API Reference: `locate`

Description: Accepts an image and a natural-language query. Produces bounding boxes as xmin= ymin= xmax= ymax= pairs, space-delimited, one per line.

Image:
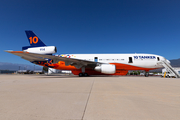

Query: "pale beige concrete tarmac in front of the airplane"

xmin=0 ymin=75 xmax=180 ymax=120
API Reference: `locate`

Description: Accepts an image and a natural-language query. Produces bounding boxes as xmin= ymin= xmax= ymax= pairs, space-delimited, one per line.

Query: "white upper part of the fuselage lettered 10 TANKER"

xmin=59 ymin=54 xmax=169 ymax=68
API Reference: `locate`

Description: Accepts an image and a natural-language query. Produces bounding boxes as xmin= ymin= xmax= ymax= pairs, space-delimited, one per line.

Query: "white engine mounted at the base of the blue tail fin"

xmin=23 ymin=46 xmax=57 ymax=54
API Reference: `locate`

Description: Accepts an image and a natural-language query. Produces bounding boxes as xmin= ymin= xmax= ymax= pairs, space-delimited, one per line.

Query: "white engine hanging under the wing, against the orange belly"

xmin=94 ymin=64 xmax=116 ymax=74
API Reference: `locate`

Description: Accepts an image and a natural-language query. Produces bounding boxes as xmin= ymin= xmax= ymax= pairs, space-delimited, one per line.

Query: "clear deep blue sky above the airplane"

xmin=0 ymin=0 xmax=180 ymax=64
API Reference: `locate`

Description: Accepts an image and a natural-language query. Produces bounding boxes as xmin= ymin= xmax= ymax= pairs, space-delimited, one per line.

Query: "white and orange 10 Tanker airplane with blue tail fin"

xmin=6 ymin=30 xmax=170 ymax=77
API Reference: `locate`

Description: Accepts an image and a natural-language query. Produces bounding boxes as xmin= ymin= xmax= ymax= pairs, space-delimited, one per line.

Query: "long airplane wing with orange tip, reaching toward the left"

xmin=5 ymin=51 xmax=100 ymax=69
